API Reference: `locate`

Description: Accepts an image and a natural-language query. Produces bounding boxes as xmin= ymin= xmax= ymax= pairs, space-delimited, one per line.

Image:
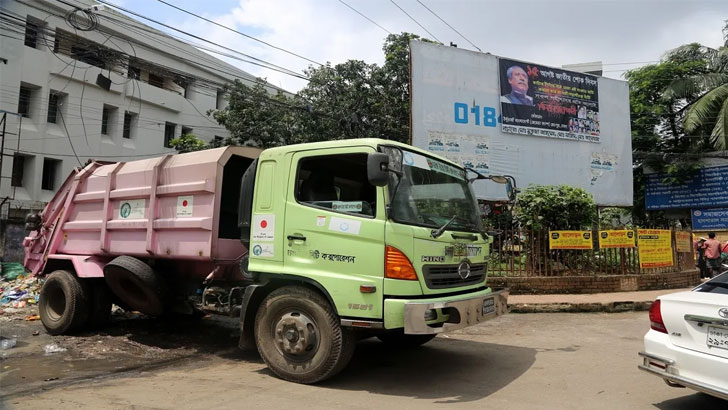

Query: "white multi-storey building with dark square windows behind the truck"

xmin=0 ymin=0 xmax=278 ymax=211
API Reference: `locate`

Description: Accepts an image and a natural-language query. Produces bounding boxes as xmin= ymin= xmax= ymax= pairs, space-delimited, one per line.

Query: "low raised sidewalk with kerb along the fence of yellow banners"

xmin=508 ymin=288 xmax=692 ymax=313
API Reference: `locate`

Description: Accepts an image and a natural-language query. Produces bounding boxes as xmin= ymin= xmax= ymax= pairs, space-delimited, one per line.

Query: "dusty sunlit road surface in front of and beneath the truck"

xmin=0 ymin=312 xmax=728 ymax=410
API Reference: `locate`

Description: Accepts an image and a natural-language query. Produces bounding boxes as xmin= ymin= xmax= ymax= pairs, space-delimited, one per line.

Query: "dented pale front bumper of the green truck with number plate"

xmin=384 ymin=288 xmax=509 ymax=335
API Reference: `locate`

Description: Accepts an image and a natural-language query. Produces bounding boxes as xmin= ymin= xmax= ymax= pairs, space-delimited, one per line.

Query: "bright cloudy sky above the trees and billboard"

xmin=109 ymin=0 xmax=728 ymax=92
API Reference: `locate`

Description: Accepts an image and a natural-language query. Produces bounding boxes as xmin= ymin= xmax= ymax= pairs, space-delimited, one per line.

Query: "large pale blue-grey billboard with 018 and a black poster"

xmin=410 ymin=41 xmax=632 ymax=206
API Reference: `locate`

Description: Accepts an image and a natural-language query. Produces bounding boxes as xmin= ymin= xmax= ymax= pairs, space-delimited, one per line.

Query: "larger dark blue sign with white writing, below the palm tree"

xmin=645 ymin=166 xmax=728 ymax=211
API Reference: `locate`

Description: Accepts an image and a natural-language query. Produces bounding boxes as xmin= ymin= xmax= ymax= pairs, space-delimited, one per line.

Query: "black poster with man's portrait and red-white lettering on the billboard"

xmin=498 ymin=58 xmax=600 ymax=142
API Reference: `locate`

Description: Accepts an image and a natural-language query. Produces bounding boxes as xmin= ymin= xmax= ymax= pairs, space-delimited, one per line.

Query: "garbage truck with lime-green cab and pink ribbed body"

xmin=23 ymin=139 xmax=515 ymax=383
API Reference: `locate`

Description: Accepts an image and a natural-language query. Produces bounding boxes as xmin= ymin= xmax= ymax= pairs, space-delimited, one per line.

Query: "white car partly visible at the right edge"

xmin=639 ymin=265 xmax=728 ymax=400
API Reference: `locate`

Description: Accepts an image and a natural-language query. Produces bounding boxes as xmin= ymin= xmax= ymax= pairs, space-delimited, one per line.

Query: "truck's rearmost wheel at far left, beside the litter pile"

xmin=38 ymin=270 xmax=88 ymax=335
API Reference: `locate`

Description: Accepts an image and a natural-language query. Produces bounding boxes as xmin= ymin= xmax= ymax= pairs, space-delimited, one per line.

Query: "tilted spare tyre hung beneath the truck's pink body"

xmin=104 ymin=256 xmax=168 ymax=316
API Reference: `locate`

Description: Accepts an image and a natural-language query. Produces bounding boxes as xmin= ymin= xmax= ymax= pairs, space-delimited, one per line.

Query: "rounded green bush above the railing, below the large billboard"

xmin=516 ymin=185 xmax=597 ymax=231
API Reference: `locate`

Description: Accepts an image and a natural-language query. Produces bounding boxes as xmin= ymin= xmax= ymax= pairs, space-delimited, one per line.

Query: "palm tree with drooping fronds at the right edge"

xmin=664 ymin=24 xmax=728 ymax=151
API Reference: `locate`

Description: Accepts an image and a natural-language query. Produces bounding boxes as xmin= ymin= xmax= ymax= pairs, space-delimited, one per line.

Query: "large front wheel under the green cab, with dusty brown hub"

xmin=255 ymin=286 xmax=356 ymax=384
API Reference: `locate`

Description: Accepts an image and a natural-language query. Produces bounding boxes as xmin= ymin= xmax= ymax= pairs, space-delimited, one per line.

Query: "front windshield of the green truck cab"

xmin=382 ymin=147 xmax=481 ymax=232
